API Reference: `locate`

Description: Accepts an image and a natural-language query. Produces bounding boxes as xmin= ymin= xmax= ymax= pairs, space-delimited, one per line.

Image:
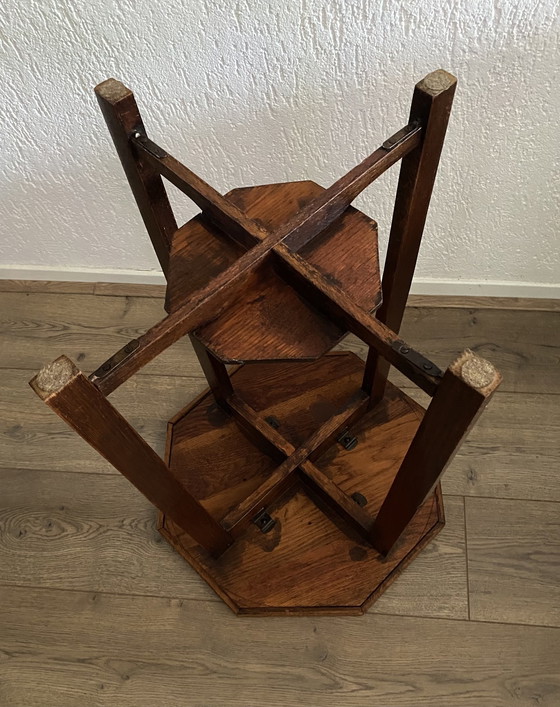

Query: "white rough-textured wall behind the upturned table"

xmin=0 ymin=0 xmax=560 ymax=290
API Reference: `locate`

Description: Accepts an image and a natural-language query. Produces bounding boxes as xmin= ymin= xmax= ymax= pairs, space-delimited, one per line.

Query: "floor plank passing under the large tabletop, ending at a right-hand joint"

xmin=0 ymin=469 xmax=467 ymax=618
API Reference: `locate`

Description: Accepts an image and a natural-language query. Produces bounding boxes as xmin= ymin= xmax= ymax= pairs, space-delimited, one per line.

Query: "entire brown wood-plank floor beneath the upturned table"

xmin=0 ymin=282 xmax=560 ymax=707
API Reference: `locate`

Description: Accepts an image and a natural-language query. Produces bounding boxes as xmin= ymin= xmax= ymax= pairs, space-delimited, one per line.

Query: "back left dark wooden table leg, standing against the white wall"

xmin=95 ymin=79 xmax=177 ymax=273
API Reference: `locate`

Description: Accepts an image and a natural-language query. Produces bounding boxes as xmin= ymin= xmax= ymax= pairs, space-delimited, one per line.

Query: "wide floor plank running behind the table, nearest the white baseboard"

xmin=0 ymin=292 xmax=560 ymax=393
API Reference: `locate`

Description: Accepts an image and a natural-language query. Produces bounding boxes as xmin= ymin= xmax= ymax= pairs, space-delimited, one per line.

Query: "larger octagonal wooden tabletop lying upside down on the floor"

xmin=159 ymin=352 xmax=445 ymax=615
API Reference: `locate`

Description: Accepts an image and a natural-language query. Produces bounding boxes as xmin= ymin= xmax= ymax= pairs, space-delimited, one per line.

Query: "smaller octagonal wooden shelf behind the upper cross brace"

xmin=167 ymin=181 xmax=381 ymax=363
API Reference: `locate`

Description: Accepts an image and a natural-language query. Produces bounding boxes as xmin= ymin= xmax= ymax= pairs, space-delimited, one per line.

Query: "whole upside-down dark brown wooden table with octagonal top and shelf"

xmin=25 ymin=71 xmax=500 ymax=614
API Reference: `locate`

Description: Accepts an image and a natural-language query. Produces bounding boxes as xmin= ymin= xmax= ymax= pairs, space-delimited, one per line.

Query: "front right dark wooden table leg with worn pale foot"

xmin=371 ymin=350 xmax=502 ymax=554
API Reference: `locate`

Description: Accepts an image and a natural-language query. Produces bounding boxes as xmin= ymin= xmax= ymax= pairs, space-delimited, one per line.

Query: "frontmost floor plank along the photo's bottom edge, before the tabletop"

xmin=0 ymin=587 xmax=560 ymax=707
